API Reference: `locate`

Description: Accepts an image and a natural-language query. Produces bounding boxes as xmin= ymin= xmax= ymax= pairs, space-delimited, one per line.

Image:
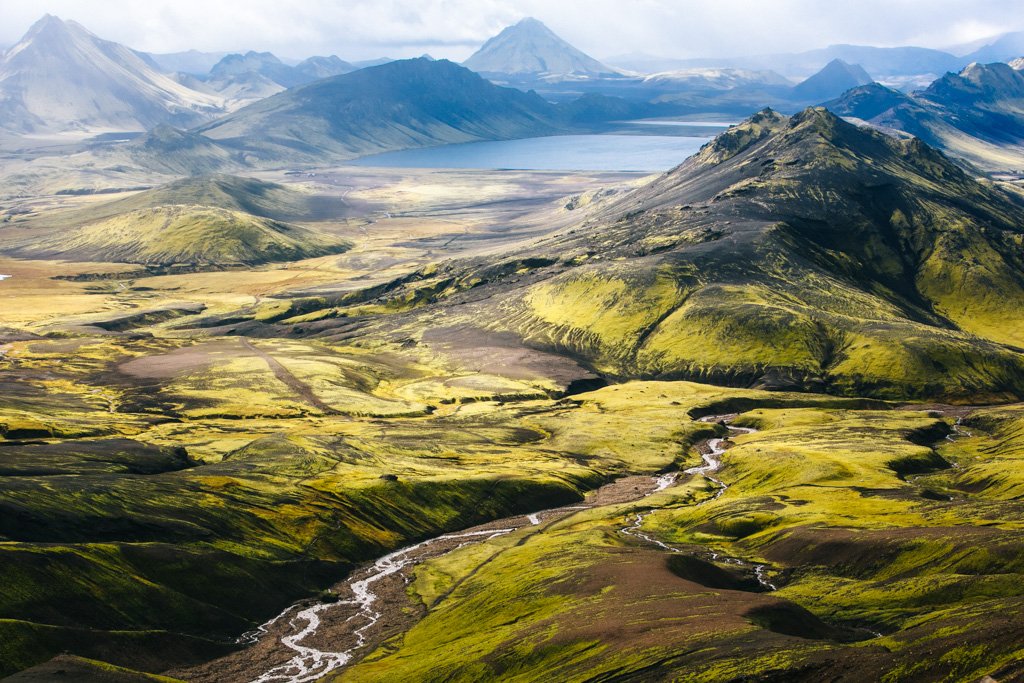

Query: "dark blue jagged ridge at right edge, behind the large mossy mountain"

xmin=826 ymin=62 xmax=1024 ymax=171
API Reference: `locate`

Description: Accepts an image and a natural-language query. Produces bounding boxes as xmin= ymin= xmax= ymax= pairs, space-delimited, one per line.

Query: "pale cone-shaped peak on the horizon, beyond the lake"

xmin=463 ymin=17 xmax=617 ymax=77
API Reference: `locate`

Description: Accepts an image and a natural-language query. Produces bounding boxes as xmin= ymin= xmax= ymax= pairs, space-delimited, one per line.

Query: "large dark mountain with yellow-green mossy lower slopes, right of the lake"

xmin=254 ymin=109 xmax=1024 ymax=401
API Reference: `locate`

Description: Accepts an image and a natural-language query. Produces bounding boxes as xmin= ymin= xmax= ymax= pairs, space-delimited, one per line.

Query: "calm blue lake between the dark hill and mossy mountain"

xmin=350 ymin=135 xmax=711 ymax=172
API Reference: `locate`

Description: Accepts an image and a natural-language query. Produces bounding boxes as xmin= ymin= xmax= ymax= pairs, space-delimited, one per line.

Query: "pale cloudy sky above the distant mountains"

xmin=0 ymin=0 xmax=1024 ymax=60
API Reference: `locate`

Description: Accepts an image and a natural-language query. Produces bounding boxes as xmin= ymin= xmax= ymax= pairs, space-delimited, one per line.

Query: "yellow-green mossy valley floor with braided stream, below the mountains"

xmin=0 ymin=168 xmax=1024 ymax=682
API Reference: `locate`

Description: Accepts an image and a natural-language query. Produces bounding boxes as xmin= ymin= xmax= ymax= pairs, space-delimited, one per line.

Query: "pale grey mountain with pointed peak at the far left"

xmin=0 ymin=14 xmax=223 ymax=133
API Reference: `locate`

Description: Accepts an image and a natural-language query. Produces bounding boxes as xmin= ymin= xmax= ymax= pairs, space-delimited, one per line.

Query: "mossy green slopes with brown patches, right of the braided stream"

xmin=336 ymin=401 xmax=1024 ymax=681
